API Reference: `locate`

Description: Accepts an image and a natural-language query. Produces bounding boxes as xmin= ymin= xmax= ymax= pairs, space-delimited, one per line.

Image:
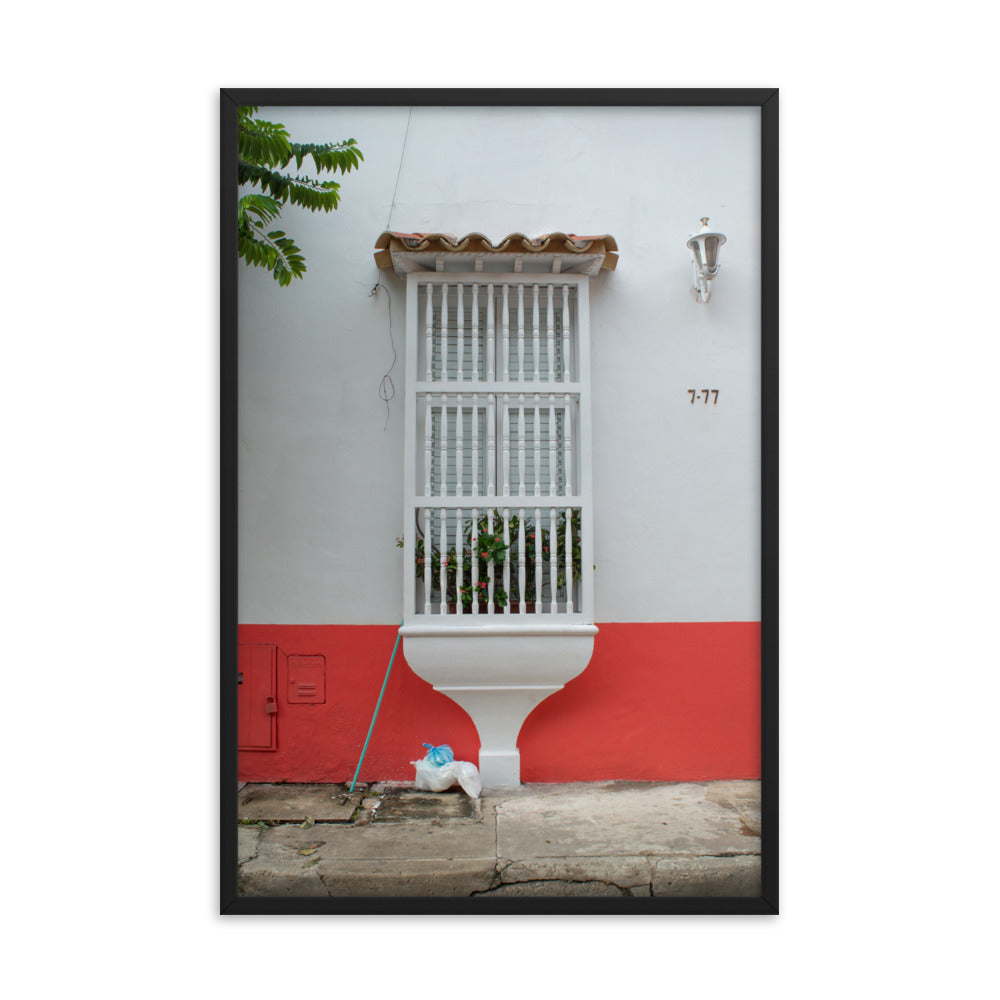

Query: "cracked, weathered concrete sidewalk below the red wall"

xmin=238 ymin=781 xmax=761 ymax=898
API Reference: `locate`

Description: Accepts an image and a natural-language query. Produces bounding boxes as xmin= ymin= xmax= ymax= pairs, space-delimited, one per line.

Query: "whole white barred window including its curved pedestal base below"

xmin=380 ymin=237 xmax=617 ymax=788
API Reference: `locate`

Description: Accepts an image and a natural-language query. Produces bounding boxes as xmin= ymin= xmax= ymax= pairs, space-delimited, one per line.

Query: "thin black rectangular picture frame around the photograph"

xmin=219 ymin=88 xmax=779 ymax=914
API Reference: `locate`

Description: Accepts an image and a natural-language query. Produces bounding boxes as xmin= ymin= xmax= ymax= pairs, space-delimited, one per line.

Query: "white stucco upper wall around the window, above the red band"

xmin=238 ymin=107 xmax=760 ymax=624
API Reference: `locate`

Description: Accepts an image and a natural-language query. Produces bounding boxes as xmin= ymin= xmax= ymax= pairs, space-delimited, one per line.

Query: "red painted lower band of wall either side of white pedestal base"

xmin=239 ymin=622 xmax=760 ymax=782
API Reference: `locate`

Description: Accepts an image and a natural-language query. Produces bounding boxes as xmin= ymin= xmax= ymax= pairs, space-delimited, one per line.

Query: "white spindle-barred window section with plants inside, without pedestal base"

xmin=404 ymin=272 xmax=593 ymax=624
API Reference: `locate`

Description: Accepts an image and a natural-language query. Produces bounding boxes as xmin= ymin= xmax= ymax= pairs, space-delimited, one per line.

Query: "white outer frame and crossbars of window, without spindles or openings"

xmin=403 ymin=271 xmax=594 ymax=632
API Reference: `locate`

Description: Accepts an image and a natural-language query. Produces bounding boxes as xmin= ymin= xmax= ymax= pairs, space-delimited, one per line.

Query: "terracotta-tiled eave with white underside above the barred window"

xmin=375 ymin=231 xmax=618 ymax=277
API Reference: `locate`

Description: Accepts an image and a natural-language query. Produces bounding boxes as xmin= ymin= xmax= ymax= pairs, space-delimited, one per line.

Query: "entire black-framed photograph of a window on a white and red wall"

xmin=220 ymin=89 xmax=778 ymax=914
